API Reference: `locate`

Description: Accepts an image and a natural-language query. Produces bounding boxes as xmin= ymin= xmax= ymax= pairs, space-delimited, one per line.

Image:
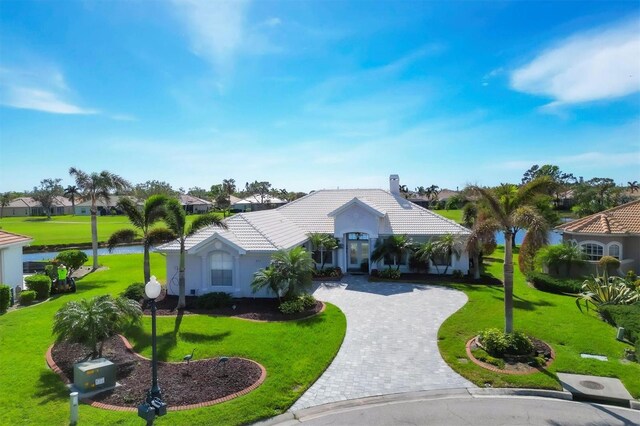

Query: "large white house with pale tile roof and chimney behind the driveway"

xmin=157 ymin=175 xmax=470 ymax=297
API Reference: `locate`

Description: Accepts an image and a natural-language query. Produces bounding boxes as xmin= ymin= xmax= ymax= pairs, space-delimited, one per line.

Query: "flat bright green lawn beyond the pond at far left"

xmin=0 ymin=215 xmax=222 ymax=245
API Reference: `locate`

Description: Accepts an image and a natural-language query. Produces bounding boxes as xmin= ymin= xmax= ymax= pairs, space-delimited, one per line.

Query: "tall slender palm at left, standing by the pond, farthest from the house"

xmin=69 ymin=167 xmax=131 ymax=270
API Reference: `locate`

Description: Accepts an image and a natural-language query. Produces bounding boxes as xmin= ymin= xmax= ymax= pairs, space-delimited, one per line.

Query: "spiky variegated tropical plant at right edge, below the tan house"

xmin=576 ymin=271 xmax=640 ymax=311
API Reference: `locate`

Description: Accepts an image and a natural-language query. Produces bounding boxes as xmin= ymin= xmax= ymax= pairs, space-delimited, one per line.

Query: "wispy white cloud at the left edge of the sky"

xmin=0 ymin=66 xmax=98 ymax=115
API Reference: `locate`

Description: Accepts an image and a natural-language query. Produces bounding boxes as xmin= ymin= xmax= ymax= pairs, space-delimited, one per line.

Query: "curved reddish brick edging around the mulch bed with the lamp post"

xmin=46 ymin=334 xmax=267 ymax=412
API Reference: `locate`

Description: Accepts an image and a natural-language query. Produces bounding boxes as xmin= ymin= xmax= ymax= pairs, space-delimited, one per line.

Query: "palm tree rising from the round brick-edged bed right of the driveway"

xmin=468 ymin=177 xmax=553 ymax=333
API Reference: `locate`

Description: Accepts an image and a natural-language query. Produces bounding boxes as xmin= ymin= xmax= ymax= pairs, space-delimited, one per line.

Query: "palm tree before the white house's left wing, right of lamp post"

xmin=164 ymin=198 xmax=227 ymax=309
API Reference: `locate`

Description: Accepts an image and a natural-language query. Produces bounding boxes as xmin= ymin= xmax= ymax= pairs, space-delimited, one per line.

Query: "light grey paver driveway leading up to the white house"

xmin=291 ymin=276 xmax=474 ymax=410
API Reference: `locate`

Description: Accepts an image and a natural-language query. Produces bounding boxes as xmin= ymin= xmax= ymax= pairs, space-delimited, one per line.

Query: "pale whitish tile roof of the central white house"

xmin=158 ymin=189 xmax=470 ymax=252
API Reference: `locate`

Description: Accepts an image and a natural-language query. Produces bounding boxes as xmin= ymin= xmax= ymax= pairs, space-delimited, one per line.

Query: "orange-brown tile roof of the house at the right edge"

xmin=556 ymin=200 xmax=640 ymax=234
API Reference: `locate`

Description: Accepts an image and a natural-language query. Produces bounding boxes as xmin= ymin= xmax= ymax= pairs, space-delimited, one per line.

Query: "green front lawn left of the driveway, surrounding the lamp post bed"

xmin=0 ymin=254 xmax=346 ymax=425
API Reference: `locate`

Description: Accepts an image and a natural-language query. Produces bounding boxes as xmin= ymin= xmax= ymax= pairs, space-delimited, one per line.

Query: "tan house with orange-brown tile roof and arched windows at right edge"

xmin=556 ymin=200 xmax=640 ymax=273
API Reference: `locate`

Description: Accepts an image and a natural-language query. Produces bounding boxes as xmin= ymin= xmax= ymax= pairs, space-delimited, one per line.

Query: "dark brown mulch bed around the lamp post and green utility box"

xmin=51 ymin=336 xmax=262 ymax=408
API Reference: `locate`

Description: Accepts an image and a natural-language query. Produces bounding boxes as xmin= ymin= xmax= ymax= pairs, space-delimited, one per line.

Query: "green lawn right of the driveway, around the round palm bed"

xmin=438 ymin=249 xmax=640 ymax=398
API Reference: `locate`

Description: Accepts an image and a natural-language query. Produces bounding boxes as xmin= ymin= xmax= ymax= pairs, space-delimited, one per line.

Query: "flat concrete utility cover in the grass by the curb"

xmin=558 ymin=373 xmax=632 ymax=404
